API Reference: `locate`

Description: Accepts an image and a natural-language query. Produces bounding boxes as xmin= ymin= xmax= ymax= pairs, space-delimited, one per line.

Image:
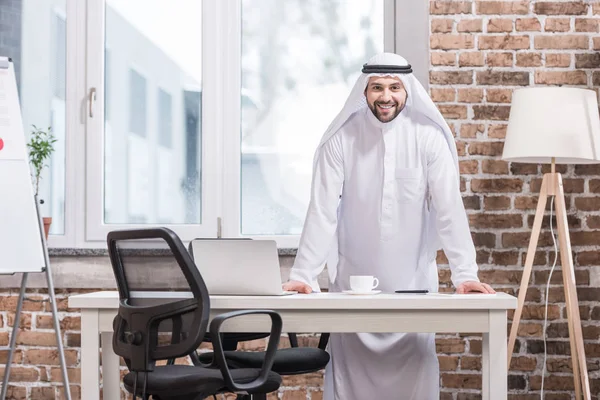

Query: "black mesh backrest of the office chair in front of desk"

xmin=107 ymin=228 xmax=210 ymax=382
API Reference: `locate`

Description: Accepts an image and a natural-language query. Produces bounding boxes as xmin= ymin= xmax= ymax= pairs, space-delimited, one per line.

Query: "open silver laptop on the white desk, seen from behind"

xmin=190 ymin=239 xmax=296 ymax=296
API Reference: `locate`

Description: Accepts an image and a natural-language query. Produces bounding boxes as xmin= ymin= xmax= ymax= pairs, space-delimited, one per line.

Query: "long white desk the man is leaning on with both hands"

xmin=69 ymin=291 xmax=517 ymax=400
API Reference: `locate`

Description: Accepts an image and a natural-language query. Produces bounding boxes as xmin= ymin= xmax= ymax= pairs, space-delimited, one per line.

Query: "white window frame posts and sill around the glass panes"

xmin=44 ymin=0 xmax=429 ymax=248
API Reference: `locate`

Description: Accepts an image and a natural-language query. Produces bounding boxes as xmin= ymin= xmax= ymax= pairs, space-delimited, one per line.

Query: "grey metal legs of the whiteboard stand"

xmin=0 ymin=198 xmax=71 ymax=400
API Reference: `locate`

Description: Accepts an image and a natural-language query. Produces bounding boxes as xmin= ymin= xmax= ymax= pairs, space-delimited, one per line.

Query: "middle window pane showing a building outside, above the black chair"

xmin=87 ymin=0 xmax=202 ymax=239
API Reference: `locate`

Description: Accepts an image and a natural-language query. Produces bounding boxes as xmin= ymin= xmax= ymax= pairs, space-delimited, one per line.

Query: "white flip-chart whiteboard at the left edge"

xmin=0 ymin=57 xmax=46 ymax=274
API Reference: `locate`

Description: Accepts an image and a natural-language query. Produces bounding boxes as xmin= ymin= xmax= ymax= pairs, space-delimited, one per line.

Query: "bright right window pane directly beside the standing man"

xmin=240 ymin=0 xmax=384 ymax=235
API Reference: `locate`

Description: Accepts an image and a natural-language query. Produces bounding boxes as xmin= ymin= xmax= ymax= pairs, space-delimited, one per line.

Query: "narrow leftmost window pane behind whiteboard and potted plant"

xmin=6 ymin=0 xmax=67 ymax=235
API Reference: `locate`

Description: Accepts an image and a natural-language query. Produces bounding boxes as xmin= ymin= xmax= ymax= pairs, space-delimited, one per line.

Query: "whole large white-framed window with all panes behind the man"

xmin=0 ymin=0 xmax=428 ymax=247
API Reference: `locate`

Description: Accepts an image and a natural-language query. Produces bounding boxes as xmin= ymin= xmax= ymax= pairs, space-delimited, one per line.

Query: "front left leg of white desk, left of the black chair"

xmin=81 ymin=309 xmax=99 ymax=400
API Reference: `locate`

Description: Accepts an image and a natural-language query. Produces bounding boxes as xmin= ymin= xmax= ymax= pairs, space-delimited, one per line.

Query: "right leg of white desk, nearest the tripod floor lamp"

xmin=481 ymin=310 xmax=508 ymax=400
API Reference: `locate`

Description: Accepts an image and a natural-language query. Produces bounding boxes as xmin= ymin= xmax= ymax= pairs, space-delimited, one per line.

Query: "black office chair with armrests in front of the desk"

xmin=107 ymin=228 xmax=282 ymax=400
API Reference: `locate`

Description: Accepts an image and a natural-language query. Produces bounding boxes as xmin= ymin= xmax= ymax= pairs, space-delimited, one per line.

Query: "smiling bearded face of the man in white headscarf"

xmin=365 ymin=76 xmax=407 ymax=122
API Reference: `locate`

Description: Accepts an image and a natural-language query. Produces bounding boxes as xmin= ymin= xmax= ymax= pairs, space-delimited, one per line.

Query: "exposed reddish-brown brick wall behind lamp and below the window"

xmin=0 ymin=1 xmax=600 ymax=400
